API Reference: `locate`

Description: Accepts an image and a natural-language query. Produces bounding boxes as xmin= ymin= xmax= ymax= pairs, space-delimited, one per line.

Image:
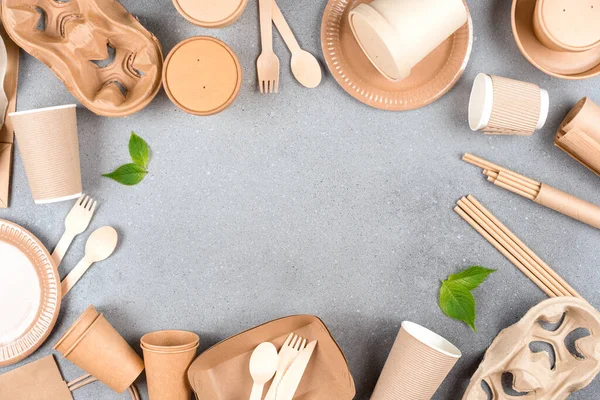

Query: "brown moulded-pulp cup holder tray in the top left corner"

xmin=2 ymin=0 xmax=163 ymax=117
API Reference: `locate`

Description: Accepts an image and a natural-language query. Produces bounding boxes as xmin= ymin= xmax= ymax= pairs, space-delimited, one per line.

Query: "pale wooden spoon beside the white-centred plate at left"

xmin=61 ymin=226 xmax=119 ymax=297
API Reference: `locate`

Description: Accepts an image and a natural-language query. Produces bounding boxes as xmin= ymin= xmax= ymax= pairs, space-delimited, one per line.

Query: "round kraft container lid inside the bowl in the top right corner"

xmin=537 ymin=0 xmax=600 ymax=51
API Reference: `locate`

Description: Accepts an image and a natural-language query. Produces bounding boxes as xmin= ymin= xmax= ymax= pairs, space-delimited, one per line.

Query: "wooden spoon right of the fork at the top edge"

xmin=273 ymin=0 xmax=322 ymax=89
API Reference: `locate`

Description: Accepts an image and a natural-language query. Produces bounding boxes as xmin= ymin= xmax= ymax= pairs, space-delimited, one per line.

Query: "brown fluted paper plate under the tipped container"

xmin=321 ymin=0 xmax=473 ymax=111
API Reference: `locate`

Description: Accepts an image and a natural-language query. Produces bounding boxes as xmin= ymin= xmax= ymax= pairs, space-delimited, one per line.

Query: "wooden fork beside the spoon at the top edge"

xmin=256 ymin=0 xmax=279 ymax=93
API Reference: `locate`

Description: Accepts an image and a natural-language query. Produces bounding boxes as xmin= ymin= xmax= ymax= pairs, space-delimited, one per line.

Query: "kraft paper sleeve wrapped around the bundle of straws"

xmin=534 ymin=183 xmax=600 ymax=229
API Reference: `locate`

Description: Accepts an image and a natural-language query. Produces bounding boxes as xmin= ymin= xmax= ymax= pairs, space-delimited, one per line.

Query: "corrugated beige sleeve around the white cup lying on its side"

xmin=483 ymin=75 xmax=542 ymax=136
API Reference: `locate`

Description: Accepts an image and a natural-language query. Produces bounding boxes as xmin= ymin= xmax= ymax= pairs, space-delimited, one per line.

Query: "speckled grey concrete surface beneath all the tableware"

xmin=0 ymin=0 xmax=600 ymax=400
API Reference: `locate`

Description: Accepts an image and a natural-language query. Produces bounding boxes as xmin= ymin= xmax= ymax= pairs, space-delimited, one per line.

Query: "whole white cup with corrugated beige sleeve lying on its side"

xmin=469 ymin=73 xmax=550 ymax=136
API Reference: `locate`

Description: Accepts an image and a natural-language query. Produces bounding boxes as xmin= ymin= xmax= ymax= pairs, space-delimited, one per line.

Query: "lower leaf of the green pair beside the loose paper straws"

xmin=440 ymin=281 xmax=477 ymax=332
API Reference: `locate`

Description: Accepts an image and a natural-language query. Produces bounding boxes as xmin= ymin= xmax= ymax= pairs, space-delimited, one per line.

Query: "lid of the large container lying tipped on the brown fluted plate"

xmin=348 ymin=4 xmax=410 ymax=81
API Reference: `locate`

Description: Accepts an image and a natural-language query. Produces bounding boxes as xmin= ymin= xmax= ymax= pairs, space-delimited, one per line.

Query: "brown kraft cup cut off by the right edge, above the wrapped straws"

xmin=554 ymin=97 xmax=600 ymax=175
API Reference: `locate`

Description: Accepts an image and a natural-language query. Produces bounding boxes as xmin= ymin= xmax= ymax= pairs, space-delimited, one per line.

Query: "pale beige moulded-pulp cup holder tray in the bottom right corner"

xmin=463 ymin=297 xmax=600 ymax=400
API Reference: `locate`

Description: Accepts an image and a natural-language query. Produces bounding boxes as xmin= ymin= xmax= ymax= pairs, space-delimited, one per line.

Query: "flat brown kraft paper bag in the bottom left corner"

xmin=0 ymin=355 xmax=73 ymax=400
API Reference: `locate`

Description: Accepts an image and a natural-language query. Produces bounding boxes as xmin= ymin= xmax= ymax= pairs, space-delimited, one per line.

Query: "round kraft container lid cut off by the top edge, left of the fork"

xmin=173 ymin=0 xmax=248 ymax=28
